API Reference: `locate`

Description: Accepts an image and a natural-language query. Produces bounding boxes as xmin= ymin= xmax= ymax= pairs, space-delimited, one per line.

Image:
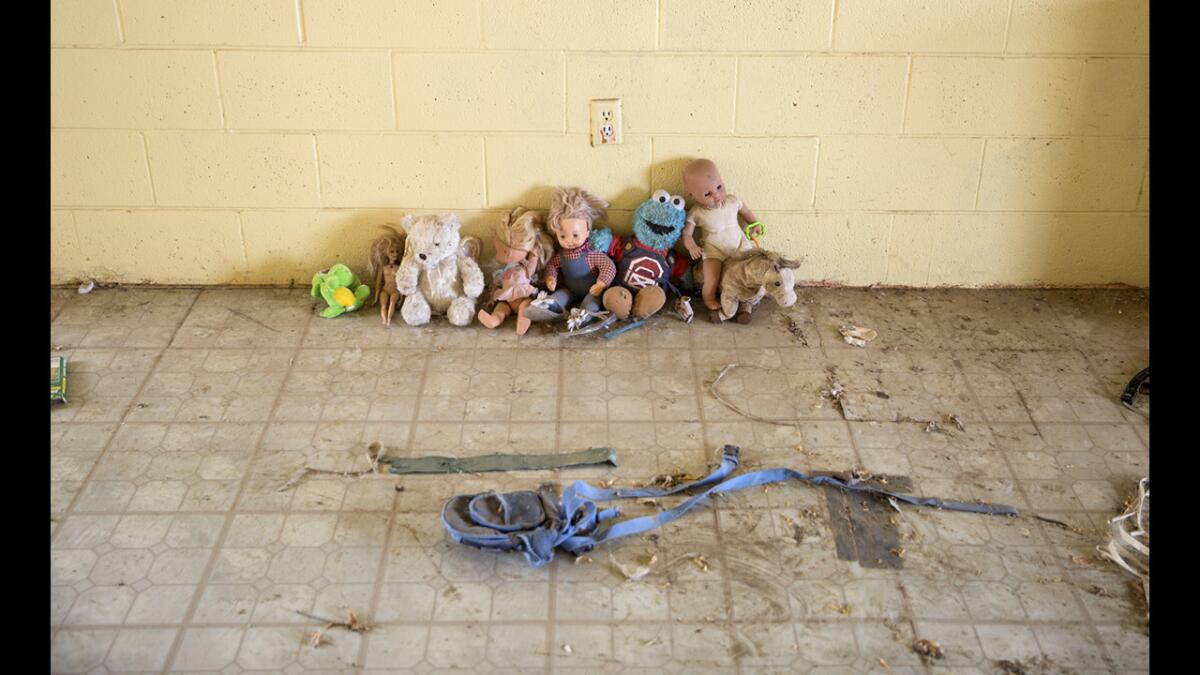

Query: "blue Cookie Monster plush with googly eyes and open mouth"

xmin=588 ymin=190 xmax=688 ymax=319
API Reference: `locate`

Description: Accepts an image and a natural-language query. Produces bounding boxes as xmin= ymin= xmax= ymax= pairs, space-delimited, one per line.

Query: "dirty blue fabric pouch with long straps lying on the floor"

xmin=442 ymin=446 xmax=1018 ymax=567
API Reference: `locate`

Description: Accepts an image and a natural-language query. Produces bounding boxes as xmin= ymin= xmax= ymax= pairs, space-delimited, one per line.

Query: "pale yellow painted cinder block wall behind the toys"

xmin=50 ymin=0 xmax=1150 ymax=286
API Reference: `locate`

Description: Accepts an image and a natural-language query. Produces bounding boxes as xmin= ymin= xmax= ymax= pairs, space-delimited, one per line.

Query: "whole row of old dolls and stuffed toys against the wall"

xmin=312 ymin=160 xmax=798 ymax=335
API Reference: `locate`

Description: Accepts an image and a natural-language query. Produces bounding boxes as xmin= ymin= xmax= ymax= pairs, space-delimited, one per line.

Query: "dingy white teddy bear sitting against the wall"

xmin=396 ymin=214 xmax=484 ymax=325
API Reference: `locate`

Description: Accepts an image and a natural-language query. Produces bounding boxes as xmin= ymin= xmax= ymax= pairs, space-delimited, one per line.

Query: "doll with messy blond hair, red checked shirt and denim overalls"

xmin=526 ymin=187 xmax=617 ymax=321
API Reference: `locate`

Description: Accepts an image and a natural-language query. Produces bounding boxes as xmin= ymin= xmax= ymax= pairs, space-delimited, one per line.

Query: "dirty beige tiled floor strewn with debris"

xmin=50 ymin=288 xmax=1148 ymax=675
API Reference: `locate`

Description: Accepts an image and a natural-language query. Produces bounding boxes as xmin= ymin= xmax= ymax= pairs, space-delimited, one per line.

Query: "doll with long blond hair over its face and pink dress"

xmin=479 ymin=207 xmax=554 ymax=335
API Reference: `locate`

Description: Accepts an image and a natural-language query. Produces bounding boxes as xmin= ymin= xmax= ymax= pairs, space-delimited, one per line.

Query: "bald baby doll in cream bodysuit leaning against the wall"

xmin=683 ymin=160 xmax=762 ymax=322
